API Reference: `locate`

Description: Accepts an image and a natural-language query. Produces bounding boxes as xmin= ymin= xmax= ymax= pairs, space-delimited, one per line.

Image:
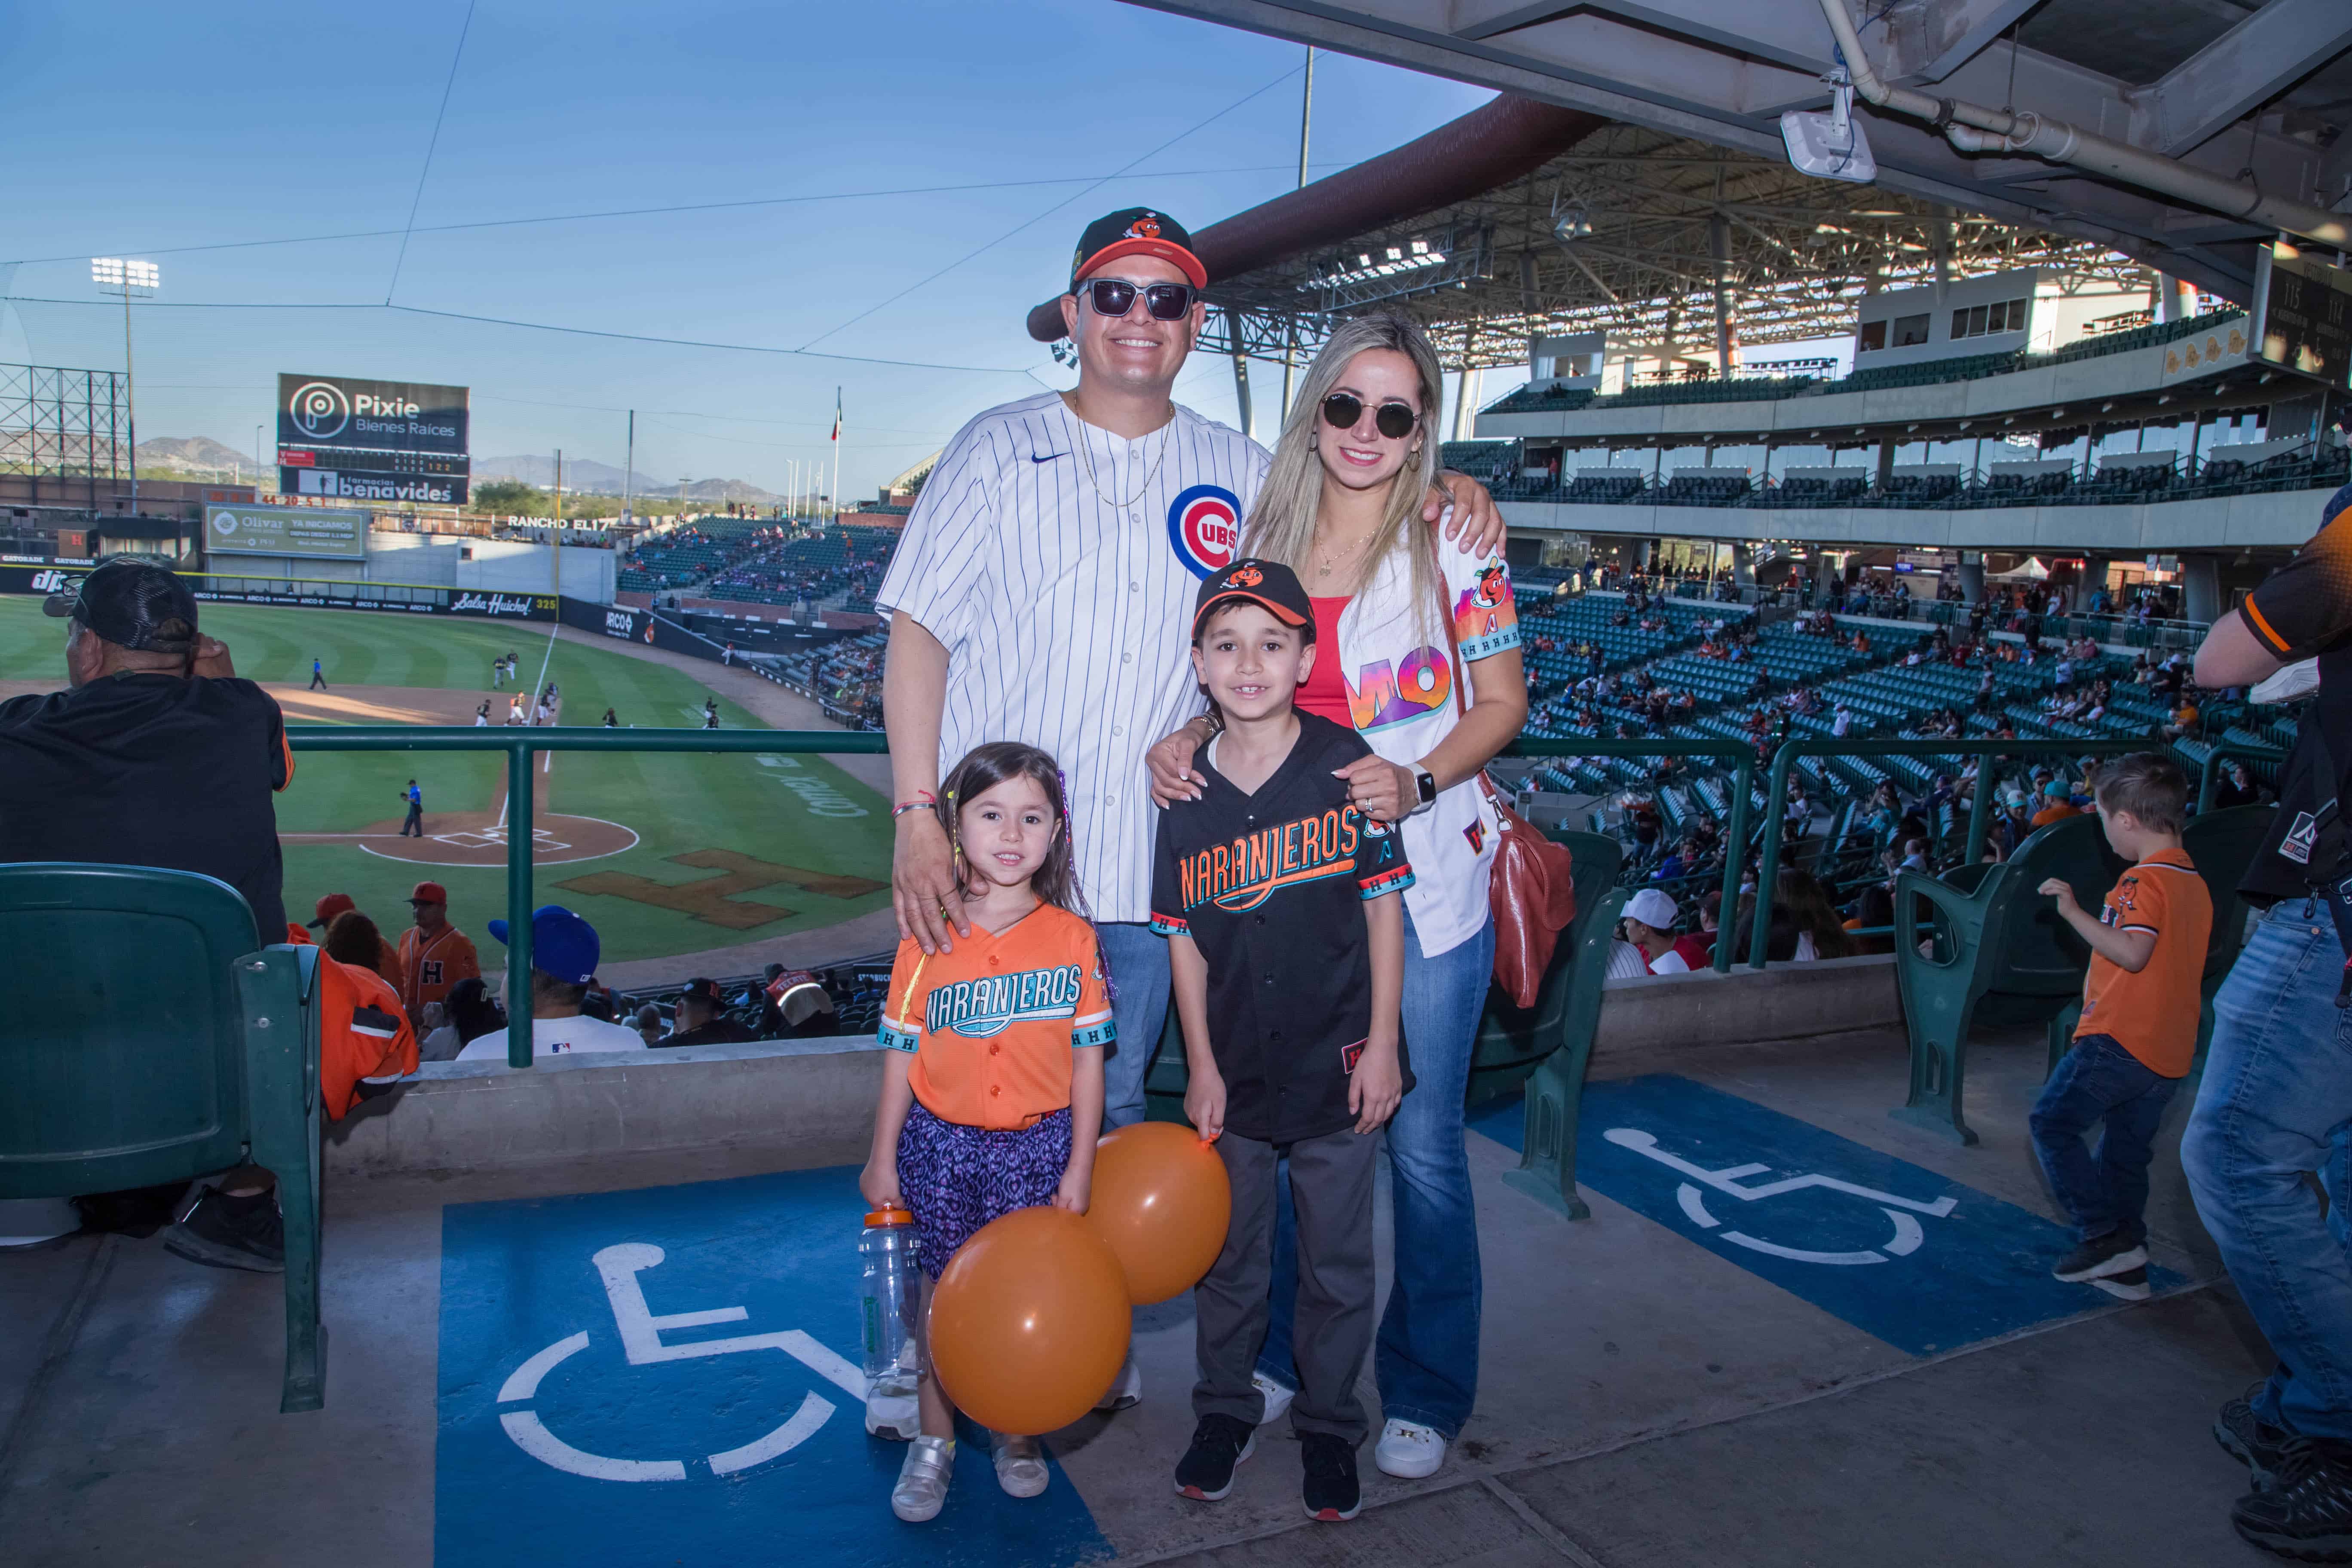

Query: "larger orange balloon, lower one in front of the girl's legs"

xmin=931 ymin=1208 xmax=1129 ymax=1436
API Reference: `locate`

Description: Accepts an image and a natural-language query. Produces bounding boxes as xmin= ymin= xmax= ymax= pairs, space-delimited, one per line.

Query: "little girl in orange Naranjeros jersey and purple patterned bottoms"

xmin=858 ymin=741 xmax=1112 ymax=1523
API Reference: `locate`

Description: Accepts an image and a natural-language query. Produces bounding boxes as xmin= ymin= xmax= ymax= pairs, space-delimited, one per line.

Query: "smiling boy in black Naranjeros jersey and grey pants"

xmin=1152 ymin=560 xmax=1414 ymax=1521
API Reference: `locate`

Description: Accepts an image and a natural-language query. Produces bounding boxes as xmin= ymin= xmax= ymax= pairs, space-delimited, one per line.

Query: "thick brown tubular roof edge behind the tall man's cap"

xmin=1028 ymin=94 xmax=1609 ymax=343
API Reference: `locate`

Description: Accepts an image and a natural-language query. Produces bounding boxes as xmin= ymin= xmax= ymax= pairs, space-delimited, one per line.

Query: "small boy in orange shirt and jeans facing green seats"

xmin=2032 ymin=752 xmax=2213 ymax=1300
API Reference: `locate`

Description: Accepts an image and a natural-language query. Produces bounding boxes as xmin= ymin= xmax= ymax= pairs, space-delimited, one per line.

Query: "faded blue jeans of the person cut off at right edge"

xmin=2180 ymin=898 xmax=2352 ymax=1441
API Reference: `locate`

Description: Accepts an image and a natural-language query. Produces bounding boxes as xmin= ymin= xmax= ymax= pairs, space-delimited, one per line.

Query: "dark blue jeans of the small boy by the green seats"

xmin=2027 ymin=1034 xmax=2180 ymax=1246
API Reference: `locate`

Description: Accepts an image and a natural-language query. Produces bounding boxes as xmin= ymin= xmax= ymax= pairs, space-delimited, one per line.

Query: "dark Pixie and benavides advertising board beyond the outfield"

xmin=278 ymin=374 xmax=473 ymax=505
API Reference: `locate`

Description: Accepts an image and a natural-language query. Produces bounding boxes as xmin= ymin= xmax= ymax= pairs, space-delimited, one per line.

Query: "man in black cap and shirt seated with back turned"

xmin=0 ymin=555 xmax=294 ymax=1272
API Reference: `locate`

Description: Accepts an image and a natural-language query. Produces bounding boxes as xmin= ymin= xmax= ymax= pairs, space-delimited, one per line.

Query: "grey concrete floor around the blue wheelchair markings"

xmin=0 ymin=1034 xmax=2269 ymax=1568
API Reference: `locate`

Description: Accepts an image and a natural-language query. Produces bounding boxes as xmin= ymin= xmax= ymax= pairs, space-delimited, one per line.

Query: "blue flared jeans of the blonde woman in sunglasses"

xmin=1259 ymin=915 xmax=1494 ymax=1443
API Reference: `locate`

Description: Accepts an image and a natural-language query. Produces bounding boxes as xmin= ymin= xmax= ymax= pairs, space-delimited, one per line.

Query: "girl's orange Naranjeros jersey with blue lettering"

xmin=882 ymin=905 xmax=1115 ymax=1131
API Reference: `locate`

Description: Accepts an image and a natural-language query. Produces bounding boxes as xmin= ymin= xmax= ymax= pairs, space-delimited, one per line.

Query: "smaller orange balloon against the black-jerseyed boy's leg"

xmin=1087 ymin=1121 xmax=1232 ymax=1307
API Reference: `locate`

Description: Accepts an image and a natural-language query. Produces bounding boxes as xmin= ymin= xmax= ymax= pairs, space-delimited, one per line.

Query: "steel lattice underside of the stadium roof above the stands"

xmin=1202 ymin=125 xmax=2152 ymax=369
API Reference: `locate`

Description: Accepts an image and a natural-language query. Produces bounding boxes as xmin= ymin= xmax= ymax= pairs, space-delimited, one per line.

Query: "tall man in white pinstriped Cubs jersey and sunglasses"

xmin=875 ymin=207 xmax=1503 ymax=1335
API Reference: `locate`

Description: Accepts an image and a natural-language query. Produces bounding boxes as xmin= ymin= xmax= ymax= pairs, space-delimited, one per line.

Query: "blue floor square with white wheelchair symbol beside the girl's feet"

xmin=433 ymin=1168 xmax=1112 ymax=1568
